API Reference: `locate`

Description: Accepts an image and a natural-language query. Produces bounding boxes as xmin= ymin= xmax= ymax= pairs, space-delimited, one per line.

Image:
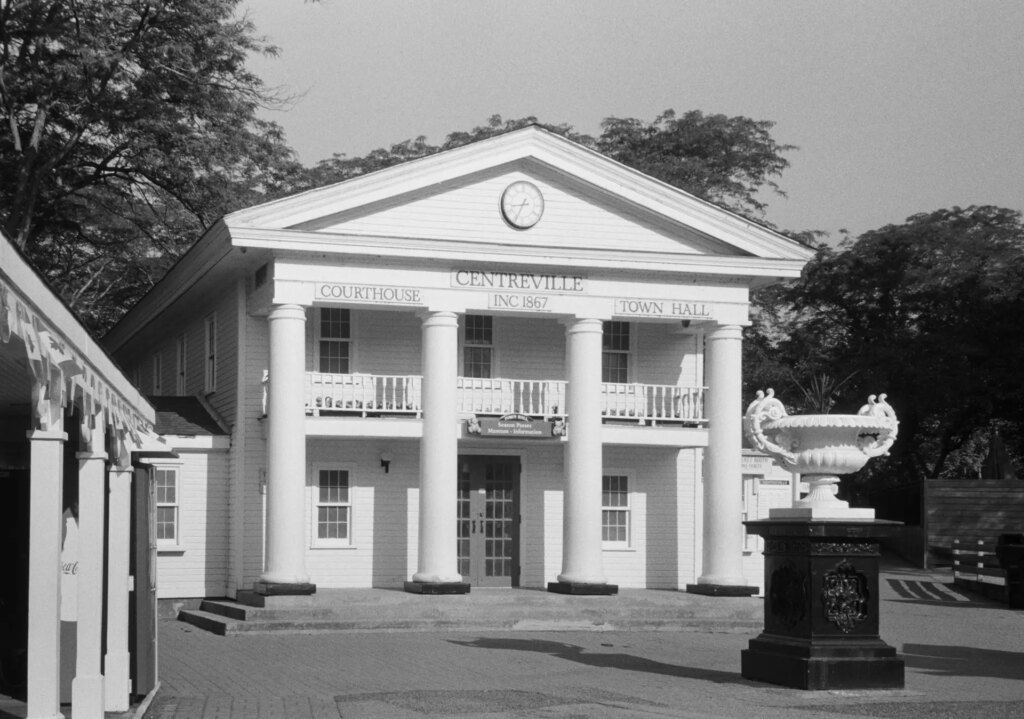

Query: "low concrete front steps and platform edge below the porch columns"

xmin=178 ymin=589 xmax=763 ymax=636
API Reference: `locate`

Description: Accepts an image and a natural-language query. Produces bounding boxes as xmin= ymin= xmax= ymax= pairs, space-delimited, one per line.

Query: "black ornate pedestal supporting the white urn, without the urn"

xmin=741 ymin=518 xmax=904 ymax=689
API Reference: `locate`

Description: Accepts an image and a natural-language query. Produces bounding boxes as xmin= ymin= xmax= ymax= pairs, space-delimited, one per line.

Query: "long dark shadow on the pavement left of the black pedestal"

xmin=449 ymin=637 xmax=746 ymax=684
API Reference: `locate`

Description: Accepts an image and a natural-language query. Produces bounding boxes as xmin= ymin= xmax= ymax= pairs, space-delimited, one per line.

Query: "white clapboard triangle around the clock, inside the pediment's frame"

xmin=323 ymin=171 xmax=723 ymax=254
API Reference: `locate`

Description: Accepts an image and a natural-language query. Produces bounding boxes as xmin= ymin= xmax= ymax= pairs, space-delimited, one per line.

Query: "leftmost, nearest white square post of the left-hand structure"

xmin=27 ymin=425 xmax=68 ymax=719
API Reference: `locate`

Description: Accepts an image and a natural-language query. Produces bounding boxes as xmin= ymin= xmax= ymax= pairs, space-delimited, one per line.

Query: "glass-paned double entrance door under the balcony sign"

xmin=458 ymin=455 xmax=519 ymax=587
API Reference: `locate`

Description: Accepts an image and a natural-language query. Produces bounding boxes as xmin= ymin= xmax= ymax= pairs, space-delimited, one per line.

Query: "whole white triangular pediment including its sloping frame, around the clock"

xmin=225 ymin=127 xmax=809 ymax=259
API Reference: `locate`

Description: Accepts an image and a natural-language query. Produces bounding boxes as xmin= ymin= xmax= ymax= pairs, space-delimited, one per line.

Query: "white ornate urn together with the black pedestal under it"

xmin=740 ymin=389 xmax=905 ymax=689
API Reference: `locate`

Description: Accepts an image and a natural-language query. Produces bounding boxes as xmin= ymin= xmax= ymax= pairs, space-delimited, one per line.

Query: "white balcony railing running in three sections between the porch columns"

xmin=306 ymin=372 xmax=706 ymax=426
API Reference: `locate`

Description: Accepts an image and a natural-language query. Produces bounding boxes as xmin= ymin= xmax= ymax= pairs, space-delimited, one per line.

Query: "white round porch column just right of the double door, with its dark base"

xmin=548 ymin=318 xmax=618 ymax=594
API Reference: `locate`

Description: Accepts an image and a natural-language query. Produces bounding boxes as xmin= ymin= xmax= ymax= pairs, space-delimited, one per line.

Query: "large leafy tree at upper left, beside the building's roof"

xmin=0 ymin=0 xmax=297 ymax=330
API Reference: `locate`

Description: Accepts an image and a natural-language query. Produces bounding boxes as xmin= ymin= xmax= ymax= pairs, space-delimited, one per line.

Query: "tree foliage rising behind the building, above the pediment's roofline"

xmin=299 ymin=110 xmax=796 ymax=223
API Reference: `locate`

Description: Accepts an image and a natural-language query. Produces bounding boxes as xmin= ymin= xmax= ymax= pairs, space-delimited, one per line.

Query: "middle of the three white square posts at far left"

xmin=71 ymin=450 xmax=106 ymax=719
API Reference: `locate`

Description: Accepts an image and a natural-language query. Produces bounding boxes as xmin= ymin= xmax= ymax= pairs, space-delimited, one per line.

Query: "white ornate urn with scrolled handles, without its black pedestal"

xmin=743 ymin=389 xmax=899 ymax=519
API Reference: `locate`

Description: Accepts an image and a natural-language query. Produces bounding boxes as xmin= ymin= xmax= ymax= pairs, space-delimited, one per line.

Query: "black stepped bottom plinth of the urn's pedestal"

xmin=739 ymin=634 xmax=904 ymax=690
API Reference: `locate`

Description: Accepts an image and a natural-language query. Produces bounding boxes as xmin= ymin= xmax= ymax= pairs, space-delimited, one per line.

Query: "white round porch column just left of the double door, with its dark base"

xmin=406 ymin=311 xmax=469 ymax=594
